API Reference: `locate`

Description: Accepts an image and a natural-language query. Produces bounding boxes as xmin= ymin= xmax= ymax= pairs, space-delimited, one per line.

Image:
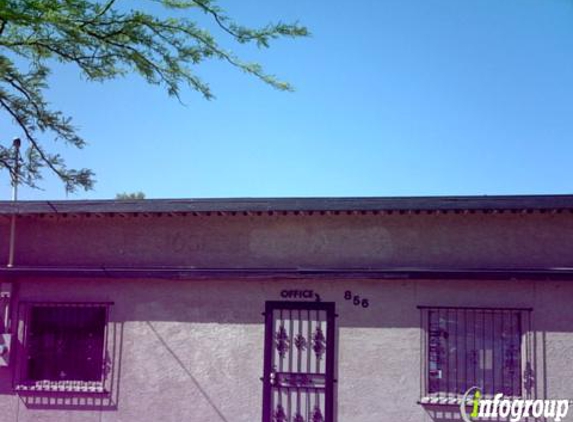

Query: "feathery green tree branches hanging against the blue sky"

xmin=0 ymin=0 xmax=308 ymax=191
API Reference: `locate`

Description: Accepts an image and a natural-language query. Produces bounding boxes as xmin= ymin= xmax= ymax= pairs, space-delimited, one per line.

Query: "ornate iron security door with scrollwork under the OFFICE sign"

xmin=263 ymin=302 xmax=335 ymax=422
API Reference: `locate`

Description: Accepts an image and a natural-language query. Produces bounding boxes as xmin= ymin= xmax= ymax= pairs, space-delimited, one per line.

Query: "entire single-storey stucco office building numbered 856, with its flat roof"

xmin=0 ymin=196 xmax=573 ymax=422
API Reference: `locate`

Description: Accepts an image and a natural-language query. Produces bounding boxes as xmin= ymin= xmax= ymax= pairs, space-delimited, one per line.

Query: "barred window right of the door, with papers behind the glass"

xmin=421 ymin=307 xmax=531 ymax=399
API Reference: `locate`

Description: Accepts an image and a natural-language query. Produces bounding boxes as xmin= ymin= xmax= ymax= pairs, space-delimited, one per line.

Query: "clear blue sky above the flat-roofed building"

xmin=0 ymin=0 xmax=573 ymax=199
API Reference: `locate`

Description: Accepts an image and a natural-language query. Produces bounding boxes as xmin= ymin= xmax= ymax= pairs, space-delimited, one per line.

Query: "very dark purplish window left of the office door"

xmin=17 ymin=303 xmax=109 ymax=393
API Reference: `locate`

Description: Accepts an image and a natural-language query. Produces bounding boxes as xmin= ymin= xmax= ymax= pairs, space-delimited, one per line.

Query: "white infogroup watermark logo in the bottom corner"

xmin=460 ymin=387 xmax=569 ymax=422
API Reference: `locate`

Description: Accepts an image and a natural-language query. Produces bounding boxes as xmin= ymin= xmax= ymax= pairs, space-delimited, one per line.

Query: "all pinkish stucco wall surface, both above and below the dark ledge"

xmin=0 ymin=213 xmax=573 ymax=422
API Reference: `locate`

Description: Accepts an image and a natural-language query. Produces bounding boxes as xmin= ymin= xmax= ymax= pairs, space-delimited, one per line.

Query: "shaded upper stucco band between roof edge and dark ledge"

xmin=0 ymin=212 xmax=573 ymax=268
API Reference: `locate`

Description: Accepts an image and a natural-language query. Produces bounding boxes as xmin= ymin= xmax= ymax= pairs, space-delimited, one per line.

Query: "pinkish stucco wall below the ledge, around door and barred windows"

xmin=0 ymin=279 xmax=573 ymax=422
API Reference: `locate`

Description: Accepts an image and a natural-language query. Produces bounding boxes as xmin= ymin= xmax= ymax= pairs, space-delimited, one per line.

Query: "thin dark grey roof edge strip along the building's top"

xmin=0 ymin=195 xmax=573 ymax=215
